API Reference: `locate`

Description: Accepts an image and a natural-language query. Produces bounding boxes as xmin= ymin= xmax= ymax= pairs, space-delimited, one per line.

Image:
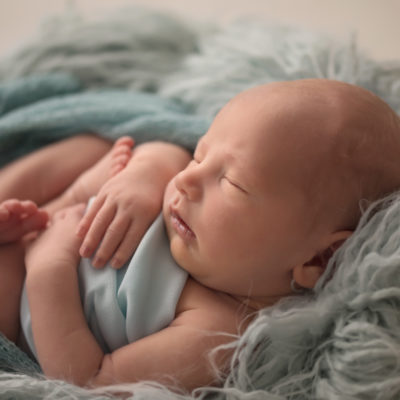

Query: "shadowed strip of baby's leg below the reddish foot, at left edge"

xmin=0 ymin=241 xmax=25 ymax=342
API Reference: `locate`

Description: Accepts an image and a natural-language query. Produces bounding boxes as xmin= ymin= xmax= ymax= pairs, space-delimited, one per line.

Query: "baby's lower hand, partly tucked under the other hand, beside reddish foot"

xmin=25 ymin=204 xmax=85 ymax=270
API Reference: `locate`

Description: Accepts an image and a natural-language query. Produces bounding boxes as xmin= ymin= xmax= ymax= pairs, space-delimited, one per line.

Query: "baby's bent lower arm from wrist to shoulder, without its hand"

xmin=27 ymin=242 xmax=237 ymax=390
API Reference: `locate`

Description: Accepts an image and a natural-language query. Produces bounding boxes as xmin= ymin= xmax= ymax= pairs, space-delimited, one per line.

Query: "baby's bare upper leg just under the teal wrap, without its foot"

xmin=0 ymin=135 xmax=111 ymax=206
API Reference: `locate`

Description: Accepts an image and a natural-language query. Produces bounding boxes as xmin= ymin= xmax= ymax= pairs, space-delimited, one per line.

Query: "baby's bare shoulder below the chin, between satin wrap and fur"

xmin=171 ymin=277 xmax=250 ymax=334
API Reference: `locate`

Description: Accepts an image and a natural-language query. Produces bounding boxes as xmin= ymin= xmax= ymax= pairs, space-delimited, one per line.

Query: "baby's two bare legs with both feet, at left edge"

xmin=0 ymin=136 xmax=133 ymax=342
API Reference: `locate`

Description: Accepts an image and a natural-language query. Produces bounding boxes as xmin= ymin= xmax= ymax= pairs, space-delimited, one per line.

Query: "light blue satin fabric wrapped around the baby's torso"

xmin=21 ymin=215 xmax=188 ymax=356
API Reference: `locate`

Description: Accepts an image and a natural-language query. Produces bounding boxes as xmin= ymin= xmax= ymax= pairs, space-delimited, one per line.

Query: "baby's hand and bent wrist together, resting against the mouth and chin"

xmin=77 ymin=142 xmax=191 ymax=268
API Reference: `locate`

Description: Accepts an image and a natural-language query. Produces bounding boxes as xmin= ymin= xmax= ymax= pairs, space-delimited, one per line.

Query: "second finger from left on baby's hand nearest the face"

xmin=79 ymin=204 xmax=116 ymax=257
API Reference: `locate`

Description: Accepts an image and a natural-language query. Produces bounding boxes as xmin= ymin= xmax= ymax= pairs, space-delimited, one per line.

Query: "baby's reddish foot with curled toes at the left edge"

xmin=0 ymin=199 xmax=49 ymax=244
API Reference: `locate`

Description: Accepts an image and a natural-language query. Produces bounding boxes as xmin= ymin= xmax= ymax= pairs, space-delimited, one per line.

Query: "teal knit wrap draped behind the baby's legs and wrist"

xmin=0 ymin=74 xmax=211 ymax=166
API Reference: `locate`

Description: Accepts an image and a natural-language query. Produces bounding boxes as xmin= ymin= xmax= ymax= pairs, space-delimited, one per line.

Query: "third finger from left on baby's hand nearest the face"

xmin=92 ymin=213 xmax=129 ymax=268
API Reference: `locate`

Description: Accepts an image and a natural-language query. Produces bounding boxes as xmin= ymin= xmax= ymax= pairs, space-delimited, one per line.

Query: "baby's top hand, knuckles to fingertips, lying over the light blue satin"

xmin=77 ymin=170 xmax=161 ymax=268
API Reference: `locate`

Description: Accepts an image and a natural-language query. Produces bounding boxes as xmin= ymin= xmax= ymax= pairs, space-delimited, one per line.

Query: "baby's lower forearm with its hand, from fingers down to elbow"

xmin=25 ymin=204 xmax=102 ymax=380
